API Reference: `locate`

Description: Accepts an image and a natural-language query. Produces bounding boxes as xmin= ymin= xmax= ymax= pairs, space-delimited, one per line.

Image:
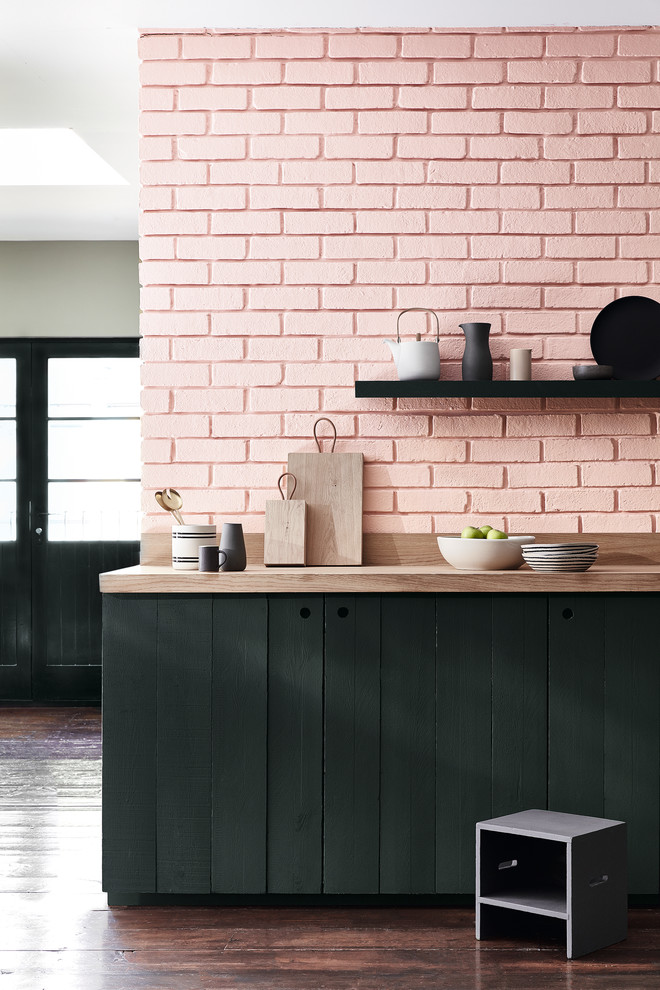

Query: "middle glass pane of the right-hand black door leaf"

xmin=48 ymin=419 xmax=140 ymax=480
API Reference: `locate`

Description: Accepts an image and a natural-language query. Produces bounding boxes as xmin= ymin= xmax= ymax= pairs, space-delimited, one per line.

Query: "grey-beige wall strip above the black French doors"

xmin=0 ymin=241 xmax=140 ymax=337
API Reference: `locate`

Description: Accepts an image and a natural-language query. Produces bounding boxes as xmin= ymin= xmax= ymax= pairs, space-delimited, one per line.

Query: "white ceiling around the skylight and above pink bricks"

xmin=0 ymin=0 xmax=660 ymax=241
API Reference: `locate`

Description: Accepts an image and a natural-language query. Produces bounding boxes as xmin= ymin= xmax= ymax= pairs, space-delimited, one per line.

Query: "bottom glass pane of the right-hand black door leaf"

xmin=48 ymin=481 xmax=140 ymax=542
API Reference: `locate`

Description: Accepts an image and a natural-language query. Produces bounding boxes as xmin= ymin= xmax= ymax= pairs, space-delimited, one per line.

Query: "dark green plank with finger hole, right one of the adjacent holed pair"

xmin=323 ymin=595 xmax=380 ymax=894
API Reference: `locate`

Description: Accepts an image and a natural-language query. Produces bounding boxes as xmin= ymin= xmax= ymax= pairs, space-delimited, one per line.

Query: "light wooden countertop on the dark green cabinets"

xmin=100 ymin=553 xmax=660 ymax=595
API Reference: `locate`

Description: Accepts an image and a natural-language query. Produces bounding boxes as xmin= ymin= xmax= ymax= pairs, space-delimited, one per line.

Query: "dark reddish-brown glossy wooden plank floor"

xmin=0 ymin=708 xmax=660 ymax=990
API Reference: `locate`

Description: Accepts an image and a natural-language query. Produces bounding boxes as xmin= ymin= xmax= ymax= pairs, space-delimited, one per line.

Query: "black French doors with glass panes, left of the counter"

xmin=0 ymin=338 xmax=140 ymax=701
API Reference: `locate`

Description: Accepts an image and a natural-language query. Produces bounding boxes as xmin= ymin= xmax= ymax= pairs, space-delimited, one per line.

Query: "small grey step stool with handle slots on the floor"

xmin=476 ymin=810 xmax=627 ymax=959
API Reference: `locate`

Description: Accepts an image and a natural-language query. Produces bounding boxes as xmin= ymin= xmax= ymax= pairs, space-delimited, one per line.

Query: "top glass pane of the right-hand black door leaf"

xmin=48 ymin=358 xmax=140 ymax=416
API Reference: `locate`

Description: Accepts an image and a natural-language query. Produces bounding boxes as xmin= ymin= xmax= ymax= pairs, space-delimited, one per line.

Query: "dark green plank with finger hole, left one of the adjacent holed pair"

xmin=268 ymin=595 xmax=323 ymax=894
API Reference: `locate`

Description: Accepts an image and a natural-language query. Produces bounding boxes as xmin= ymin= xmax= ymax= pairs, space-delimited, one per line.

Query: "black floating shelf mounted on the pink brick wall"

xmin=355 ymin=380 xmax=660 ymax=399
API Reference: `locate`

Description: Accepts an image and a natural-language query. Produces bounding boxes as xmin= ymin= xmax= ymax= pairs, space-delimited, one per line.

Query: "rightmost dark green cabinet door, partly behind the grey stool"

xmin=548 ymin=595 xmax=660 ymax=894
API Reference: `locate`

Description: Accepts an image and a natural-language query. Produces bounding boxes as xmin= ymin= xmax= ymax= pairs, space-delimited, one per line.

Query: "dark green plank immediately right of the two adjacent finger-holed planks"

xmin=380 ymin=595 xmax=435 ymax=894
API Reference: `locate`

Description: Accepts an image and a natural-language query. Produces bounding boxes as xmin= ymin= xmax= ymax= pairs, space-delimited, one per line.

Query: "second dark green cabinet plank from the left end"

xmin=157 ymin=595 xmax=212 ymax=893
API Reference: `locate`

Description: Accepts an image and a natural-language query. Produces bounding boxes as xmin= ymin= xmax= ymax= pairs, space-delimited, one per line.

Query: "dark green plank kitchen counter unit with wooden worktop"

xmin=101 ymin=534 xmax=660 ymax=904
